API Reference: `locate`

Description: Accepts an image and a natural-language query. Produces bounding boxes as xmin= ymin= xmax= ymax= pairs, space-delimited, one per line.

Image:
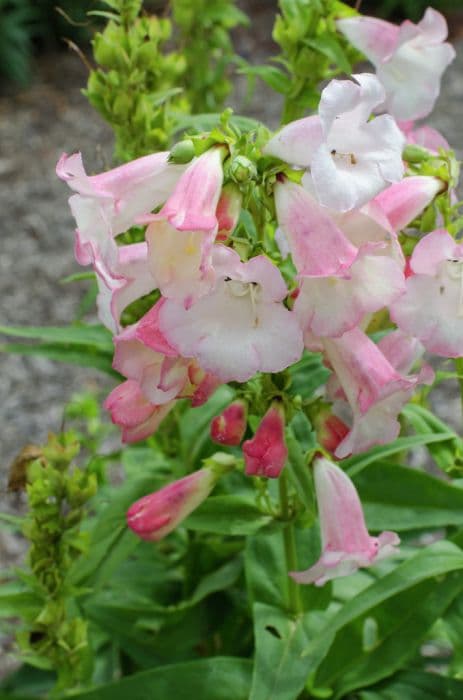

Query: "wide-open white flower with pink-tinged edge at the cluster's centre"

xmin=159 ymin=245 xmax=303 ymax=382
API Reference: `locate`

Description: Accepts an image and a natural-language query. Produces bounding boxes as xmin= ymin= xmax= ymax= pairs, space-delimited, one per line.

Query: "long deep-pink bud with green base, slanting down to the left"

xmin=127 ymin=467 xmax=218 ymax=542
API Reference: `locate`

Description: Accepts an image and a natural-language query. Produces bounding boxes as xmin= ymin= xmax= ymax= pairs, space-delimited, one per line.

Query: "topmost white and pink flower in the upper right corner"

xmin=337 ymin=7 xmax=455 ymax=120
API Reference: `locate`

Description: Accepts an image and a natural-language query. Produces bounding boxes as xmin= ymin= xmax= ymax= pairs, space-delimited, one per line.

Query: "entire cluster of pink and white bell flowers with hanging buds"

xmin=58 ymin=10 xmax=463 ymax=583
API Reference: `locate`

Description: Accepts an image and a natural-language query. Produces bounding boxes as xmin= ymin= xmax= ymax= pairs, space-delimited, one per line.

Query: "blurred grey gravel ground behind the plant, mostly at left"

xmin=0 ymin=2 xmax=463 ymax=675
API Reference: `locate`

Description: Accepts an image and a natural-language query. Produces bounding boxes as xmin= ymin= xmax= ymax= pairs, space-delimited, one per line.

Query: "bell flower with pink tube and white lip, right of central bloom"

xmin=275 ymin=182 xmax=405 ymax=337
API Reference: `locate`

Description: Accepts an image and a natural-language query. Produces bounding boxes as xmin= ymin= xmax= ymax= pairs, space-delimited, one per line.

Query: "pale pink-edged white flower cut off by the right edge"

xmin=391 ymin=229 xmax=463 ymax=357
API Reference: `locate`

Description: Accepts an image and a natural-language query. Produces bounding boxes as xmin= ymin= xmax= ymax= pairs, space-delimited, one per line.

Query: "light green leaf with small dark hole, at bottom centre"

xmin=249 ymin=603 xmax=315 ymax=700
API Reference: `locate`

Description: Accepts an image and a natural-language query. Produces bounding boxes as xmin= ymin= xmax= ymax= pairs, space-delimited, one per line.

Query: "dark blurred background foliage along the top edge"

xmin=0 ymin=0 xmax=463 ymax=87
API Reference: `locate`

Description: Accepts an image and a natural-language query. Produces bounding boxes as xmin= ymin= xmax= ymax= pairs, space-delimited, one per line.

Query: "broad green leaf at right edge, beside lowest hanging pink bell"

xmin=354 ymin=462 xmax=463 ymax=531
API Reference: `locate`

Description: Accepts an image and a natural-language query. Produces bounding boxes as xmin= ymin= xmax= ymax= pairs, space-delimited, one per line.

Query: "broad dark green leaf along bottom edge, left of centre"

xmin=70 ymin=656 xmax=252 ymax=700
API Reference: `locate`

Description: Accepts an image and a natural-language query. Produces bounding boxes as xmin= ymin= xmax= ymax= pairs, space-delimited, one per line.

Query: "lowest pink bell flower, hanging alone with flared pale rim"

xmin=290 ymin=458 xmax=400 ymax=586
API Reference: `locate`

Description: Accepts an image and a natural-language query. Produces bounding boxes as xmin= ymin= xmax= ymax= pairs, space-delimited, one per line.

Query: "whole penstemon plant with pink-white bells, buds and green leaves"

xmin=4 ymin=0 xmax=463 ymax=700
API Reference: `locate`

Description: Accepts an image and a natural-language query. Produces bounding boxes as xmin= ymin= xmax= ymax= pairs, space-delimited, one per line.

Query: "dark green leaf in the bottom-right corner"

xmin=358 ymin=671 xmax=463 ymax=700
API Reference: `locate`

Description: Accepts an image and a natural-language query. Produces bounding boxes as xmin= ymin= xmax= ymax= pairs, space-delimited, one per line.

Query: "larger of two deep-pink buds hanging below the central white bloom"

xmin=243 ymin=404 xmax=288 ymax=479
